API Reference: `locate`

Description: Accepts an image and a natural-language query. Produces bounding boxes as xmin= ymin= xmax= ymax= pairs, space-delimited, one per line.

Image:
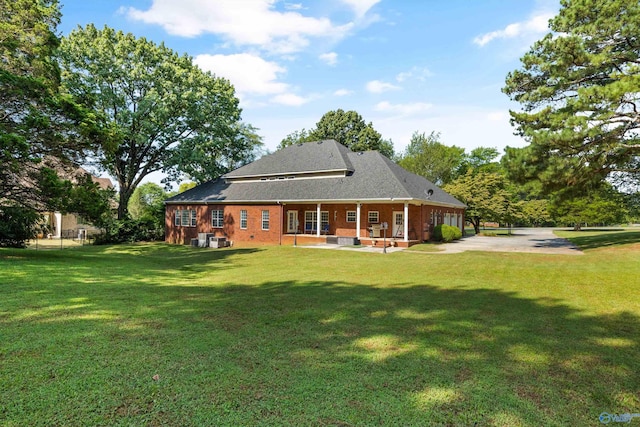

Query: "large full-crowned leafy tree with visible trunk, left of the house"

xmin=60 ymin=25 xmax=260 ymax=218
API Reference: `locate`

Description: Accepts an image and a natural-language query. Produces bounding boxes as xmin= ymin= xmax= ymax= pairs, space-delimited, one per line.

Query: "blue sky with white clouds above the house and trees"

xmin=58 ymin=0 xmax=559 ymax=157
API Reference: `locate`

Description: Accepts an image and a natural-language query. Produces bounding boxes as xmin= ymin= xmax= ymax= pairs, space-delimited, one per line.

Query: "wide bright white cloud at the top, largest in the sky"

xmin=126 ymin=0 xmax=352 ymax=54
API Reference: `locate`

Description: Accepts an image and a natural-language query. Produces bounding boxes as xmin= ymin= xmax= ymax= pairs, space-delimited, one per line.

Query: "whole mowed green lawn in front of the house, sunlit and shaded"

xmin=0 ymin=232 xmax=640 ymax=426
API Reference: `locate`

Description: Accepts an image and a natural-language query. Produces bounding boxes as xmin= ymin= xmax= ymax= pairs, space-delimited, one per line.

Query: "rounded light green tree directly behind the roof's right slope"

xmin=398 ymin=131 xmax=465 ymax=185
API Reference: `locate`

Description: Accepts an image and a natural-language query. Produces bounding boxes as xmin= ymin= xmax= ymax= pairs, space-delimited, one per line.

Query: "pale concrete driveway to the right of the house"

xmin=437 ymin=228 xmax=583 ymax=255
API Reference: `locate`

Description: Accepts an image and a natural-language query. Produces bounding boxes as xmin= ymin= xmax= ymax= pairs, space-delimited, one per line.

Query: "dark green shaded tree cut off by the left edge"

xmin=0 ymin=0 xmax=96 ymax=245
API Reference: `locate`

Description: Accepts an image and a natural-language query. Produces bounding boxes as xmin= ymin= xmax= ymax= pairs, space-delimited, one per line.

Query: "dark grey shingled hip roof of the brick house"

xmin=166 ymin=140 xmax=465 ymax=207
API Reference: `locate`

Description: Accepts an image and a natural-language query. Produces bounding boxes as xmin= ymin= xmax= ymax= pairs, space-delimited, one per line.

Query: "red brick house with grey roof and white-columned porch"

xmin=165 ymin=140 xmax=465 ymax=247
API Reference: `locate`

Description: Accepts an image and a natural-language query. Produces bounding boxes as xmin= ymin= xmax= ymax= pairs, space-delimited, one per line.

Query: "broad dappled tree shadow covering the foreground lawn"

xmin=0 ymin=268 xmax=640 ymax=425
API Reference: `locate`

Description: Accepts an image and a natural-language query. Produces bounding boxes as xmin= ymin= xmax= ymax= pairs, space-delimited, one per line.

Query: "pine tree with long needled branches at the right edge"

xmin=503 ymin=0 xmax=640 ymax=196
